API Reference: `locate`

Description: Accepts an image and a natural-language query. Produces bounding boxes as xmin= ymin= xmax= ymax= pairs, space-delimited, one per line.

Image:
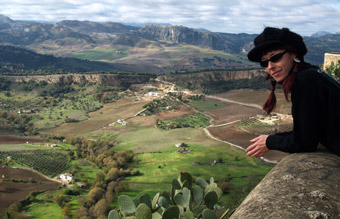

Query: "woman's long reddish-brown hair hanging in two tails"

xmin=263 ymin=62 xmax=301 ymax=114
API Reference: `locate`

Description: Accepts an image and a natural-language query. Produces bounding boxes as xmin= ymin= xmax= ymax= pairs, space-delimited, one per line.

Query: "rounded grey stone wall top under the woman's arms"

xmin=230 ymin=152 xmax=340 ymax=219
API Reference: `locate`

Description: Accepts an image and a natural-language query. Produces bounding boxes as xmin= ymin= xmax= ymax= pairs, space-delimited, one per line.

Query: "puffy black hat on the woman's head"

xmin=248 ymin=27 xmax=307 ymax=62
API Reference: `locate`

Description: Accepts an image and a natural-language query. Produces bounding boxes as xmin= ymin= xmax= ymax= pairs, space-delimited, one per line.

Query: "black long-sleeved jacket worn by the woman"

xmin=266 ymin=64 xmax=340 ymax=156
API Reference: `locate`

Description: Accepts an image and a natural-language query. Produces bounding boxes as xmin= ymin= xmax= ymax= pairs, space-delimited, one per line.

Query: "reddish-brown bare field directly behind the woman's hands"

xmin=208 ymin=125 xmax=287 ymax=161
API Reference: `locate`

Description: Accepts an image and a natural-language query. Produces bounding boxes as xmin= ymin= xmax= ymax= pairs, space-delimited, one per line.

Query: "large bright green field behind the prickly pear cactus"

xmin=89 ymin=123 xmax=272 ymax=210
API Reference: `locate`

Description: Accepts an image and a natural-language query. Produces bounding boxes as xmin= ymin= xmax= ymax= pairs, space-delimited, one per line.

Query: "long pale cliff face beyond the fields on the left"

xmin=6 ymin=74 xmax=153 ymax=85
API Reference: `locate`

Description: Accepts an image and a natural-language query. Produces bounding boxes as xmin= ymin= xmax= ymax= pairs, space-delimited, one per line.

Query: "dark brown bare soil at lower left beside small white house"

xmin=0 ymin=165 xmax=60 ymax=216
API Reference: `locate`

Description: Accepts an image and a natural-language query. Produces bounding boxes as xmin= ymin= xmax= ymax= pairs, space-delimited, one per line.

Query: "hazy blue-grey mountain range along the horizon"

xmin=0 ymin=15 xmax=340 ymax=73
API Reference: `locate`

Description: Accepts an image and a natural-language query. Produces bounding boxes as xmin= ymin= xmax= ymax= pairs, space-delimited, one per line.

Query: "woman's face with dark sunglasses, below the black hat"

xmin=260 ymin=49 xmax=296 ymax=82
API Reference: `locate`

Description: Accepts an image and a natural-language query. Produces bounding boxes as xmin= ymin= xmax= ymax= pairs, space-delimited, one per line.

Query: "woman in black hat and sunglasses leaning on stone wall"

xmin=246 ymin=27 xmax=340 ymax=157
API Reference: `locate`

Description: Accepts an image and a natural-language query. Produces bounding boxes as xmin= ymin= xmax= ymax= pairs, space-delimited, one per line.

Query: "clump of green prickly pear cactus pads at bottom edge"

xmin=108 ymin=173 xmax=228 ymax=219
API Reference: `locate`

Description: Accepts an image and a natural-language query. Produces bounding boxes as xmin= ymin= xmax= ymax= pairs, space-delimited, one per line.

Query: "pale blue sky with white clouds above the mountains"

xmin=0 ymin=0 xmax=340 ymax=36
